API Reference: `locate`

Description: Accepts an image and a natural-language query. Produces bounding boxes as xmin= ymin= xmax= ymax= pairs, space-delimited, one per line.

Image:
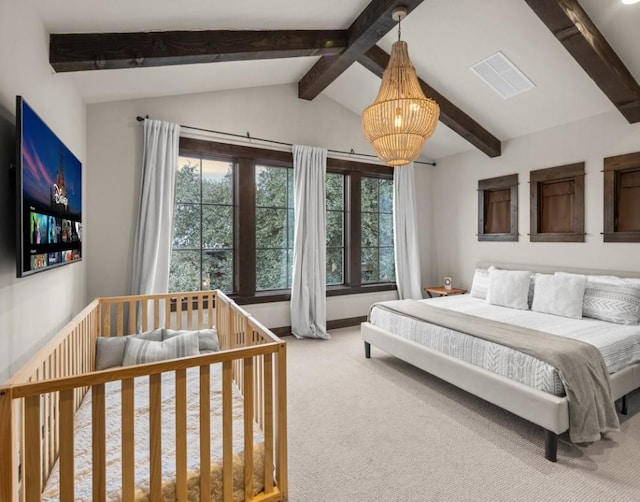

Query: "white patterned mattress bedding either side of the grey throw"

xmin=370 ymin=295 xmax=640 ymax=396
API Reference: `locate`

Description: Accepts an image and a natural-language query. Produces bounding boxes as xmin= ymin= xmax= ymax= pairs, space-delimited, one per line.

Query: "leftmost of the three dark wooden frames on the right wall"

xmin=478 ymin=174 xmax=518 ymax=242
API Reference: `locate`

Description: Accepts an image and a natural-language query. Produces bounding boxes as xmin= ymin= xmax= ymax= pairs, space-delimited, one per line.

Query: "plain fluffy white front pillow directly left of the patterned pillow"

xmin=531 ymin=273 xmax=587 ymax=319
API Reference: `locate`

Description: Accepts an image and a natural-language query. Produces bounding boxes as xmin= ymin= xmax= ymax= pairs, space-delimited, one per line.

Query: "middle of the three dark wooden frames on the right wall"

xmin=529 ymin=162 xmax=585 ymax=242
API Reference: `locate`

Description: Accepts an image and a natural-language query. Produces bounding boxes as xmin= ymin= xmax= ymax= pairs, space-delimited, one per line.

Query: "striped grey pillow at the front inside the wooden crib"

xmin=122 ymin=332 xmax=200 ymax=366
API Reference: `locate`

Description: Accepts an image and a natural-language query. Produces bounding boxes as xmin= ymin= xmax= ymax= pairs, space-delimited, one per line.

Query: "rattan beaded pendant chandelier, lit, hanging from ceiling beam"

xmin=362 ymin=7 xmax=440 ymax=166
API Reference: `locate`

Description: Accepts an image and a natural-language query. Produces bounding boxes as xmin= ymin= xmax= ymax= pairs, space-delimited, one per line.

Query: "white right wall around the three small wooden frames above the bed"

xmin=419 ymin=111 xmax=640 ymax=287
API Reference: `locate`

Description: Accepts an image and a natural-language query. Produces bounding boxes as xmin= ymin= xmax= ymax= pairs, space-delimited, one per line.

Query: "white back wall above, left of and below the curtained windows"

xmin=87 ymin=85 xmax=402 ymax=327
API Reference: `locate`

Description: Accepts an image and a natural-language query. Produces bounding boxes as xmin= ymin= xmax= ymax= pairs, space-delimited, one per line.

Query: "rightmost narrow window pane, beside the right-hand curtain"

xmin=360 ymin=176 xmax=396 ymax=284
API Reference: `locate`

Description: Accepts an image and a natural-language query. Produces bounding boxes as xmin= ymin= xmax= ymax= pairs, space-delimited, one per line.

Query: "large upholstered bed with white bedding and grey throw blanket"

xmin=361 ymin=269 xmax=640 ymax=461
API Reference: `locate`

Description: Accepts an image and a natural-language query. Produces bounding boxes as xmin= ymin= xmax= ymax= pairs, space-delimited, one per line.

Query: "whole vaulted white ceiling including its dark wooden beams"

xmin=32 ymin=0 xmax=640 ymax=159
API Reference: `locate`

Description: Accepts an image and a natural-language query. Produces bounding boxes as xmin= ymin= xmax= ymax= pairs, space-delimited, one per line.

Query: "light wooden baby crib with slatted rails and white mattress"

xmin=0 ymin=291 xmax=287 ymax=502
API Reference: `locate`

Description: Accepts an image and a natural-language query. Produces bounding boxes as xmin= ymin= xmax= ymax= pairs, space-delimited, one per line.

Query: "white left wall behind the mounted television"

xmin=0 ymin=1 xmax=87 ymax=382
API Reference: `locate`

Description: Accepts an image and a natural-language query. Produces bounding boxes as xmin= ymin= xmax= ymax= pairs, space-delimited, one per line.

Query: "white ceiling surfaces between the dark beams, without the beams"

xmin=29 ymin=0 xmax=640 ymax=159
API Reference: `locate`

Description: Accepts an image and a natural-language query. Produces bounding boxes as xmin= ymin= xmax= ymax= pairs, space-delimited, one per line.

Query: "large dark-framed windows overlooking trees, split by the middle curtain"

xmin=170 ymin=138 xmax=395 ymax=303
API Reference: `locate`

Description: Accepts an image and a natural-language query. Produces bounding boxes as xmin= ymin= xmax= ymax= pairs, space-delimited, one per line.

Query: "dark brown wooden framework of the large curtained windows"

xmin=179 ymin=137 xmax=397 ymax=305
